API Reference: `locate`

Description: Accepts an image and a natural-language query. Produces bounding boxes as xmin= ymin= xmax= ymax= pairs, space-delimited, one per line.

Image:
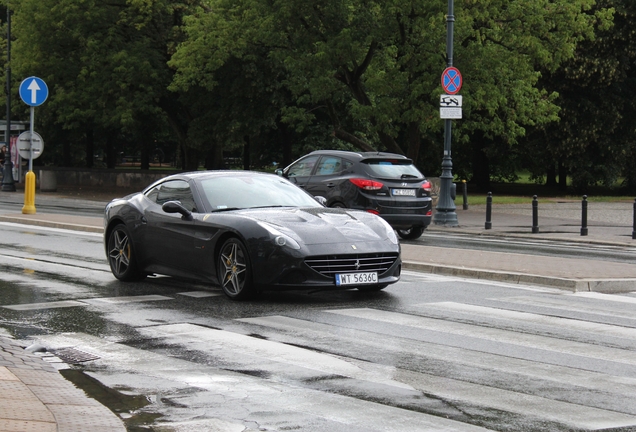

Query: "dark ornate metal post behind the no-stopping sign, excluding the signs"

xmin=433 ymin=0 xmax=458 ymax=226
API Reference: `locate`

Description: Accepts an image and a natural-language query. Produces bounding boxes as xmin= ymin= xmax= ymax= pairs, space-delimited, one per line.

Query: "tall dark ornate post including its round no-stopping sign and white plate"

xmin=433 ymin=0 xmax=462 ymax=226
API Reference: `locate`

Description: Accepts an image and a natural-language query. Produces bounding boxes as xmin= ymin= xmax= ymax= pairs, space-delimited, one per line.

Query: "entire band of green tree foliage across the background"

xmin=0 ymin=0 xmax=636 ymax=182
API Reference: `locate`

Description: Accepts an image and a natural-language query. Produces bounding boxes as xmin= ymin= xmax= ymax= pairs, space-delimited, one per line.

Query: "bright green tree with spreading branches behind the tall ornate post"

xmin=171 ymin=0 xmax=609 ymax=174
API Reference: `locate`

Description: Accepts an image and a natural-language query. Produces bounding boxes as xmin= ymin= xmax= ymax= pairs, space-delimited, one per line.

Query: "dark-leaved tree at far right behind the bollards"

xmin=526 ymin=0 xmax=636 ymax=192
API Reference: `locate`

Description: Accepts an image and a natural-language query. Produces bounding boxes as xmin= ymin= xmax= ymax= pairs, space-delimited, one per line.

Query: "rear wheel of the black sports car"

xmin=108 ymin=224 xmax=146 ymax=282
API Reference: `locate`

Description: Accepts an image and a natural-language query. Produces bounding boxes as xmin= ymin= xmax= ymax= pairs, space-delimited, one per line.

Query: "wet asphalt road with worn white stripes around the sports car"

xmin=0 ymin=223 xmax=636 ymax=432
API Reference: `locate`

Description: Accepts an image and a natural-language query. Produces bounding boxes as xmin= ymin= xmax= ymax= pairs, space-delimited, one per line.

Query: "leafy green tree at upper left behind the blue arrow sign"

xmin=3 ymin=0 xmax=201 ymax=167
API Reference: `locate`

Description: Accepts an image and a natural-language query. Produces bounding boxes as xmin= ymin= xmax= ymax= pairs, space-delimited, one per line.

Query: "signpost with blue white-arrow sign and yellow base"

xmin=18 ymin=77 xmax=49 ymax=214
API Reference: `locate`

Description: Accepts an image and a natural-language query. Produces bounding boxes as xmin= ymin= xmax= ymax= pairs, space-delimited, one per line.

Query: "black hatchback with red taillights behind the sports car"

xmin=277 ymin=150 xmax=433 ymax=240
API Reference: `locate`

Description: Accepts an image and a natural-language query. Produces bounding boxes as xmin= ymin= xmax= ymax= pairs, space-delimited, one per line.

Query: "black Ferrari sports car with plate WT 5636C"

xmin=104 ymin=171 xmax=401 ymax=300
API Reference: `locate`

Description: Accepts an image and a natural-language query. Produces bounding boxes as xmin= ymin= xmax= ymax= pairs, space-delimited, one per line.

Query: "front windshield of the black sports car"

xmin=200 ymin=174 xmax=322 ymax=211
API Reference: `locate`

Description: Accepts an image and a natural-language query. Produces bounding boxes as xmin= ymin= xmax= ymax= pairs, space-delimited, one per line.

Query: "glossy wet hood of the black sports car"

xmin=240 ymin=207 xmax=387 ymax=245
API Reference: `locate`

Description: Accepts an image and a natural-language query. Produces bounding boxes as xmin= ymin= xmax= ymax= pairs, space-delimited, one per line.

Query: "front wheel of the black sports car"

xmin=217 ymin=237 xmax=254 ymax=300
